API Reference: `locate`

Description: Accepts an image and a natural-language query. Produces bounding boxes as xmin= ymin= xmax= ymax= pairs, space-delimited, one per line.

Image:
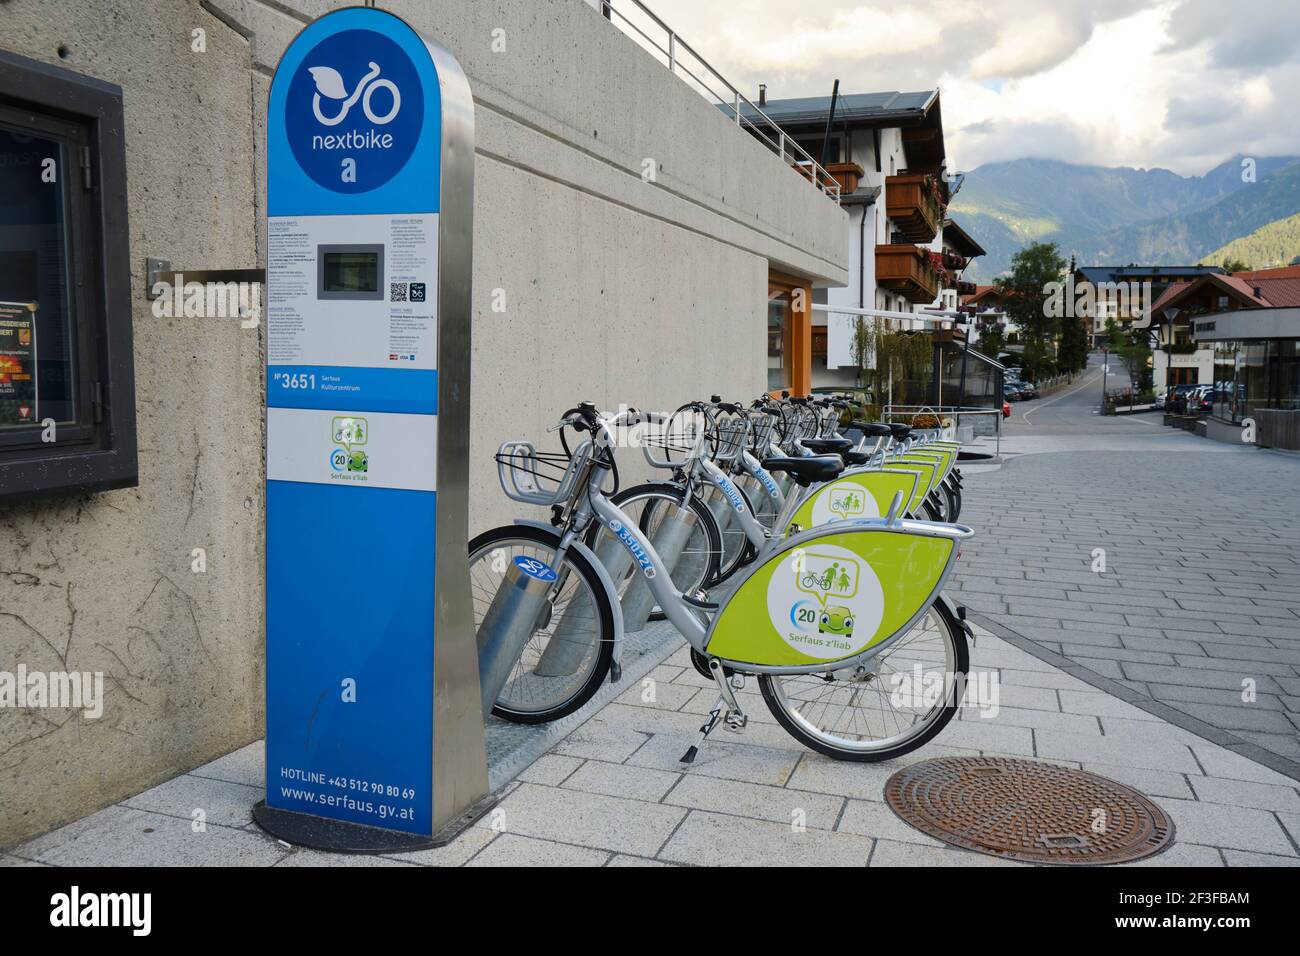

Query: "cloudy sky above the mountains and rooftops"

xmin=634 ymin=0 xmax=1300 ymax=176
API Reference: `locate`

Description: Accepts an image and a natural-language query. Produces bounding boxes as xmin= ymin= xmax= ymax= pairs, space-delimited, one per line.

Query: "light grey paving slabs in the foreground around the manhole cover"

xmin=10 ymin=628 xmax=1300 ymax=866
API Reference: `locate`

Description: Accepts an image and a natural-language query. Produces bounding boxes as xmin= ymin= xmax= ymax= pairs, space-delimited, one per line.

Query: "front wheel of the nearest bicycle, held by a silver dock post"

xmin=469 ymin=525 xmax=614 ymax=723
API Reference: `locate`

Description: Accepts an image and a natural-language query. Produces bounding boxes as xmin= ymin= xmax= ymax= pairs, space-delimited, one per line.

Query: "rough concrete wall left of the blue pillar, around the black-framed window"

xmin=0 ymin=0 xmax=263 ymax=844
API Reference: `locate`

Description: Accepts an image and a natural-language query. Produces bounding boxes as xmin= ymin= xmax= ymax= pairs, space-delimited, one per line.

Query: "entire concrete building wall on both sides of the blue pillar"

xmin=0 ymin=0 xmax=848 ymax=845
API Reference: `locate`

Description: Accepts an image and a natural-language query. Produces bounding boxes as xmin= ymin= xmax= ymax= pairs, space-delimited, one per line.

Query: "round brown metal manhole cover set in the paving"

xmin=885 ymin=757 xmax=1174 ymax=865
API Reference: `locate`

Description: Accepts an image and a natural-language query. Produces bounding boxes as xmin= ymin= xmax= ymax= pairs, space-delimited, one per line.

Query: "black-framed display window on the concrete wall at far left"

xmin=0 ymin=52 xmax=137 ymax=502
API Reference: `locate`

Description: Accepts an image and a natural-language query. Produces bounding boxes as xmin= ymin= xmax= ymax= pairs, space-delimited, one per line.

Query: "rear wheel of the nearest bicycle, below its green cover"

xmin=758 ymin=601 xmax=970 ymax=762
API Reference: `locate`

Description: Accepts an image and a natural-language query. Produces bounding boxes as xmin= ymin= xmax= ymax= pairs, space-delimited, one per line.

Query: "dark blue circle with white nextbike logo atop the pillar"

xmin=285 ymin=30 xmax=424 ymax=193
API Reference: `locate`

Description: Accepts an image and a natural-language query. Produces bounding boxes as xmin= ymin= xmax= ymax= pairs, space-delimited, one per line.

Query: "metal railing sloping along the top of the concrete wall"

xmin=599 ymin=0 xmax=840 ymax=203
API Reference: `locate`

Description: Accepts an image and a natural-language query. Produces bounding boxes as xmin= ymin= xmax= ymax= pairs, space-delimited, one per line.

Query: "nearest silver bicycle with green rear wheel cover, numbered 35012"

xmin=472 ymin=403 xmax=974 ymax=762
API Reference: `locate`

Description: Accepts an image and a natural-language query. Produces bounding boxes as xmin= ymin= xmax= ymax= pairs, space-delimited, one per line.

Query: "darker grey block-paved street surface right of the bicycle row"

xmin=950 ymin=442 xmax=1300 ymax=775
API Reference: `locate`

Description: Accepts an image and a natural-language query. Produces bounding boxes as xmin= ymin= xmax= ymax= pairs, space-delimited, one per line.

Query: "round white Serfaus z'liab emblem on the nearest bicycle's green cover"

xmin=767 ymin=546 xmax=884 ymax=661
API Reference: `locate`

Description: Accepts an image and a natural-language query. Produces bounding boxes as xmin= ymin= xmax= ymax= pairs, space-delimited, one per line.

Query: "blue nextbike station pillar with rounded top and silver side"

xmin=255 ymin=8 xmax=489 ymax=851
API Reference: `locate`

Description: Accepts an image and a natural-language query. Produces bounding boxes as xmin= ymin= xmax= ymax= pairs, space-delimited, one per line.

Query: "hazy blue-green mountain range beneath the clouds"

xmin=949 ymin=156 xmax=1300 ymax=282
